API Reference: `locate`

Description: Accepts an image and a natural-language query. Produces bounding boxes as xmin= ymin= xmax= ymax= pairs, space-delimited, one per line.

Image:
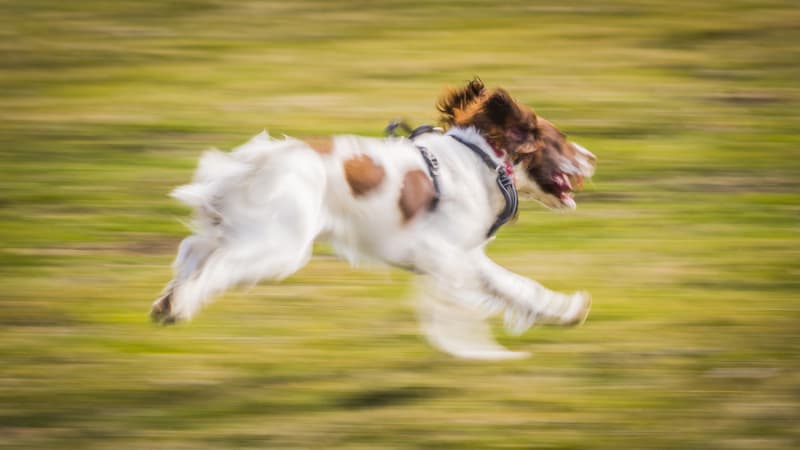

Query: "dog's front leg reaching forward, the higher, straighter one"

xmin=473 ymin=251 xmax=591 ymax=333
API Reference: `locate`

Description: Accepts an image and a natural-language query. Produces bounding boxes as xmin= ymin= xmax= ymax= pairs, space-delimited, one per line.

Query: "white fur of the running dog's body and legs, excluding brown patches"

xmin=156 ymin=128 xmax=589 ymax=359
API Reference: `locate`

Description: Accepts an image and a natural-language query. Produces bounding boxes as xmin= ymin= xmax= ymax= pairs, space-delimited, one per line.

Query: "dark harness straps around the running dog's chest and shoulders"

xmin=386 ymin=121 xmax=519 ymax=238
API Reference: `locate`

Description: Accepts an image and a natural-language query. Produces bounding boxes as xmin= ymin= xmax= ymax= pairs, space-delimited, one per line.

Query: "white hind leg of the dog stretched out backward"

xmin=151 ymin=144 xmax=325 ymax=323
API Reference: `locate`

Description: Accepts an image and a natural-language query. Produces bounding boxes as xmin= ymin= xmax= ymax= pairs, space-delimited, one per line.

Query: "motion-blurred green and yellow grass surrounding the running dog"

xmin=0 ymin=0 xmax=800 ymax=450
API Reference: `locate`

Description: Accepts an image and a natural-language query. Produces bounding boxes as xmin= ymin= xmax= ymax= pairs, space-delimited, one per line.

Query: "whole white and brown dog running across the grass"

xmin=151 ymin=79 xmax=595 ymax=359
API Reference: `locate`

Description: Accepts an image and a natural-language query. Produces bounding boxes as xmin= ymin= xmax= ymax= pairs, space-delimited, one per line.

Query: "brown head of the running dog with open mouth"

xmin=437 ymin=78 xmax=596 ymax=208
